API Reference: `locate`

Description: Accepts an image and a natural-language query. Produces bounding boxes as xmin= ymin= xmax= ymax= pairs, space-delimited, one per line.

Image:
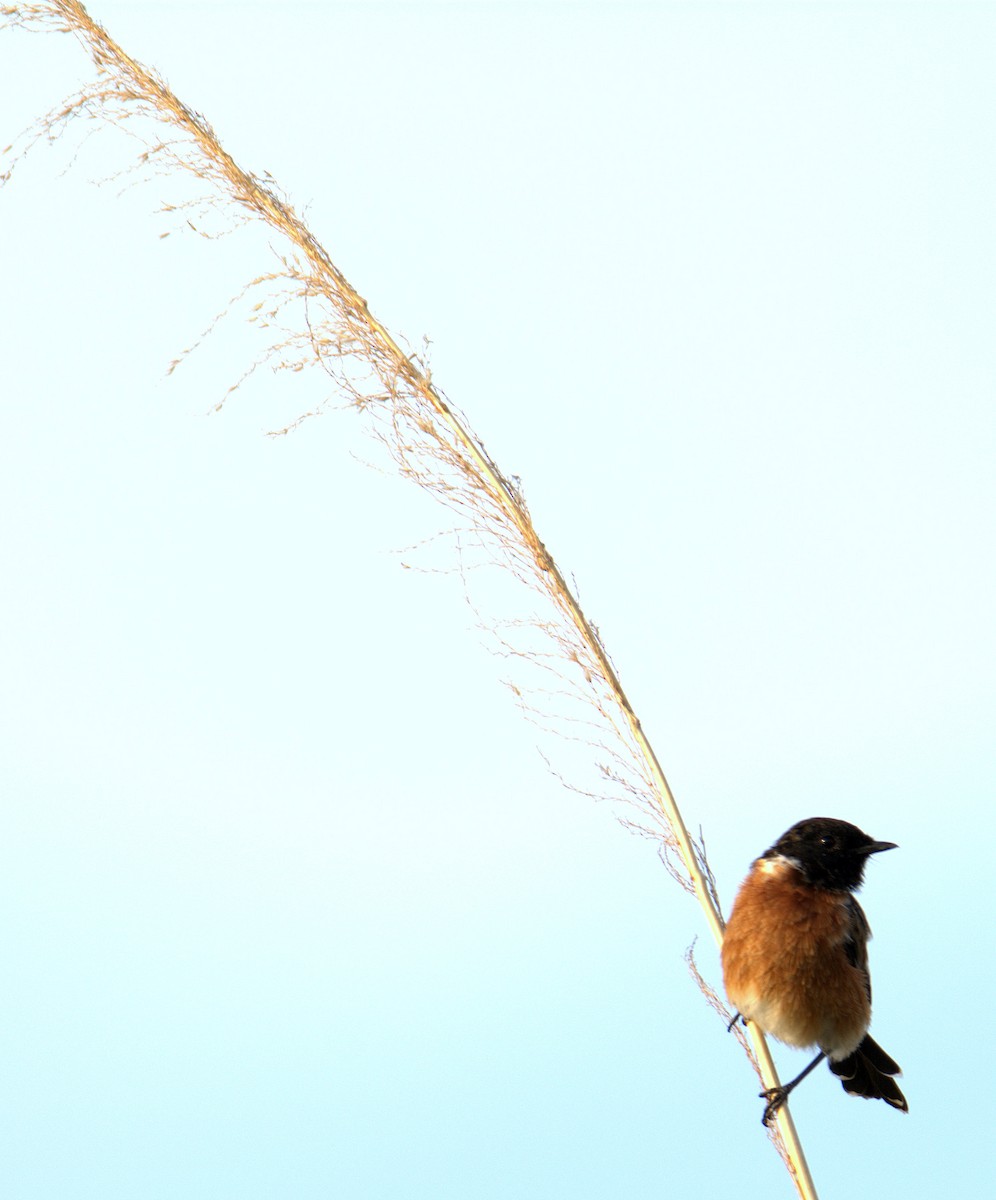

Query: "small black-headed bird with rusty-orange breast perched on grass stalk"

xmin=721 ymin=817 xmax=910 ymax=1126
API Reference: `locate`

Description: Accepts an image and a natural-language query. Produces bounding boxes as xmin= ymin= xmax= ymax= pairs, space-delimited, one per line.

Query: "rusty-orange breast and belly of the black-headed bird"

xmin=722 ymin=859 xmax=871 ymax=1060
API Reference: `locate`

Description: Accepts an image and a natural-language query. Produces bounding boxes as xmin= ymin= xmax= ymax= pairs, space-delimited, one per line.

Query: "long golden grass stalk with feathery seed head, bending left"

xmin=0 ymin=0 xmax=816 ymax=1200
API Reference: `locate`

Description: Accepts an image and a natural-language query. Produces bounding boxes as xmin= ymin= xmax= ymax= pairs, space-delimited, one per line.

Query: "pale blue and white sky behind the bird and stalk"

xmin=0 ymin=0 xmax=996 ymax=1200
